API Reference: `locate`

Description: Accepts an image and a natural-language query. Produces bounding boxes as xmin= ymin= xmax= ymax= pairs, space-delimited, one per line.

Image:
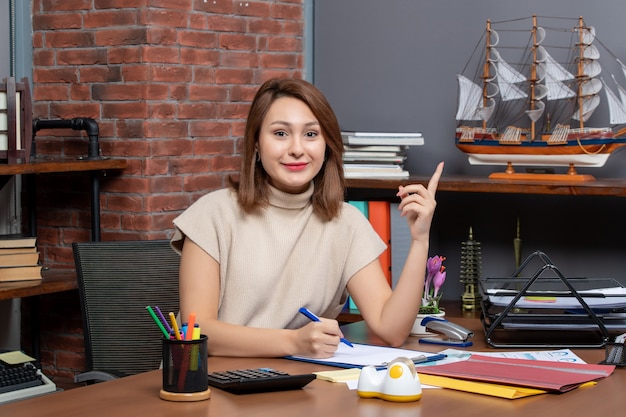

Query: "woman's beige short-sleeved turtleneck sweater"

xmin=172 ymin=185 xmax=386 ymax=328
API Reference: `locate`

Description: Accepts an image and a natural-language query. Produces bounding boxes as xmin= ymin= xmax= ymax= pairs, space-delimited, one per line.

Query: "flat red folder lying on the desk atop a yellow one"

xmin=417 ymin=355 xmax=615 ymax=392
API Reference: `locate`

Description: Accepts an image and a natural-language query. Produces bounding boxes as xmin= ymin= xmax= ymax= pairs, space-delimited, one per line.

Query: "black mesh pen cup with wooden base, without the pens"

xmin=159 ymin=335 xmax=211 ymax=401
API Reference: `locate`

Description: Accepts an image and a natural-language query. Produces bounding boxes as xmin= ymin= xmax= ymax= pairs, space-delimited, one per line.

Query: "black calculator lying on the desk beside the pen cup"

xmin=208 ymin=368 xmax=315 ymax=394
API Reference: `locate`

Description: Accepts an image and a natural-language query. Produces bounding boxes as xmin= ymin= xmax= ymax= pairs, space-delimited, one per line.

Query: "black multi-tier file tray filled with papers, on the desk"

xmin=479 ymin=251 xmax=626 ymax=348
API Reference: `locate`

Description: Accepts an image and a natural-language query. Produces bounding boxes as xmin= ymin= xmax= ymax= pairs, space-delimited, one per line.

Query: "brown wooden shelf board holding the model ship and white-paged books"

xmin=347 ymin=175 xmax=626 ymax=199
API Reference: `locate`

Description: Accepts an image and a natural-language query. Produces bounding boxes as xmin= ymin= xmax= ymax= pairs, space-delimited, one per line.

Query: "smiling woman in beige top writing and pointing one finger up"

xmin=172 ymin=79 xmax=443 ymax=358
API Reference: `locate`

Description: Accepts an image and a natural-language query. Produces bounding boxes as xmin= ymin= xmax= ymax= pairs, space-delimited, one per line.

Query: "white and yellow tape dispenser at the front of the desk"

xmin=357 ymin=357 xmax=422 ymax=402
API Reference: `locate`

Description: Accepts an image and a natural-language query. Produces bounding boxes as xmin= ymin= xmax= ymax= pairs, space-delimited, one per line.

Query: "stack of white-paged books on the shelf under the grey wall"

xmin=341 ymin=132 xmax=424 ymax=178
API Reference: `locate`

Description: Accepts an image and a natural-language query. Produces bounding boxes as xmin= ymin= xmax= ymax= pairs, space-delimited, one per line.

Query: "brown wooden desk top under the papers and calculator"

xmin=0 ymin=318 xmax=626 ymax=417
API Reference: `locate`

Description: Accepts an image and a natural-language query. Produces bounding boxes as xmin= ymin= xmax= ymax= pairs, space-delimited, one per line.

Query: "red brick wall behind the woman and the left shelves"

xmin=24 ymin=0 xmax=304 ymax=376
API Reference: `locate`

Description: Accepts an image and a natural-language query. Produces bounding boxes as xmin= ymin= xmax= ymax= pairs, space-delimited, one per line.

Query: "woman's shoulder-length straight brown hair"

xmin=230 ymin=79 xmax=345 ymax=220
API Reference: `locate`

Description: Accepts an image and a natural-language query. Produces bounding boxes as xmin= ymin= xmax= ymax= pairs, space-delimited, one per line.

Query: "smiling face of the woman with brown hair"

xmin=258 ymin=97 xmax=326 ymax=193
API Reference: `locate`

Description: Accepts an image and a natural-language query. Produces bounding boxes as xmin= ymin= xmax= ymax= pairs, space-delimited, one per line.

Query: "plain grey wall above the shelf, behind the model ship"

xmin=314 ymin=0 xmax=626 ymax=177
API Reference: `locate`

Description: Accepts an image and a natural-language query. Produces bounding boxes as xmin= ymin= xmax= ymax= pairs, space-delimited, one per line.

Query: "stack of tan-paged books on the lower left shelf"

xmin=0 ymin=235 xmax=41 ymax=282
